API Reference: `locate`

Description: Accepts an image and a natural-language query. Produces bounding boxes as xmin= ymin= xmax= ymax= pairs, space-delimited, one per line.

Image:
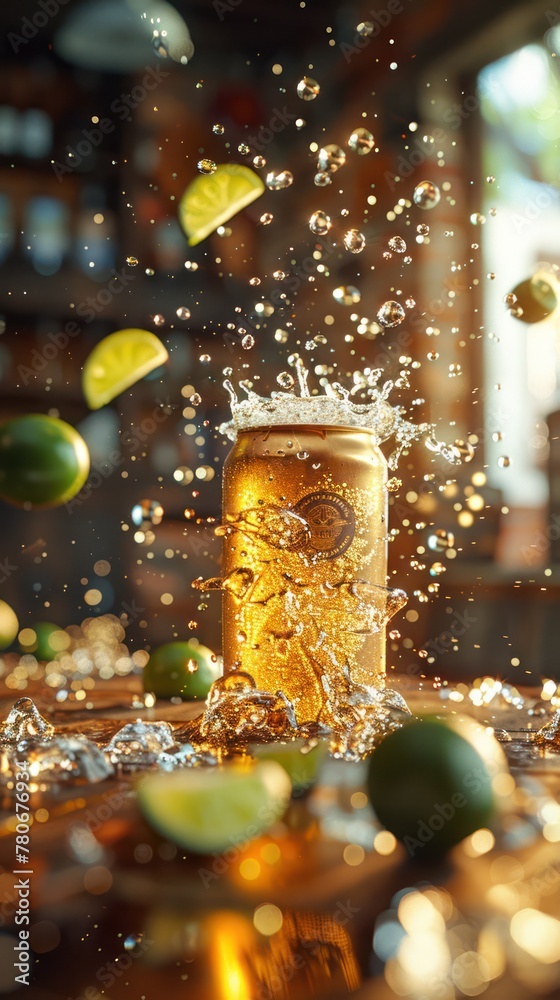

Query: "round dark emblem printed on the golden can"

xmin=293 ymin=490 xmax=356 ymax=559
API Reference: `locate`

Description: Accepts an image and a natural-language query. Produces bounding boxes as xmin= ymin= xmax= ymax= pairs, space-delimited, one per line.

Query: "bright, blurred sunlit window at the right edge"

xmin=478 ymin=39 xmax=560 ymax=507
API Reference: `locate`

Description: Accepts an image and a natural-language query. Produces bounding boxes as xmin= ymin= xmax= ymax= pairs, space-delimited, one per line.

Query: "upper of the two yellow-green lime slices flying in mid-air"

xmin=179 ymin=163 xmax=265 ymax=247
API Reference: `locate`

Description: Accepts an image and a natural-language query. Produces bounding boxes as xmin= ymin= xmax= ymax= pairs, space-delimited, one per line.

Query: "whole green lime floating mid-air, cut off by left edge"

xmin=0 ymin=413 xmax=89 ymax=507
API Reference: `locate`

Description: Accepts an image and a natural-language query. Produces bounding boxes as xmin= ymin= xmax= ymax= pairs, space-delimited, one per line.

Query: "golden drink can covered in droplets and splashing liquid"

xmin=222 ymin=425 xmax=389 ymax=723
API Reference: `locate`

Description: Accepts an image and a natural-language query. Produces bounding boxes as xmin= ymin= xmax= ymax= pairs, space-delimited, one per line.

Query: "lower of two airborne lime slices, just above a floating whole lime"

xmin=82 ymin=330 xmax=169 ymax=410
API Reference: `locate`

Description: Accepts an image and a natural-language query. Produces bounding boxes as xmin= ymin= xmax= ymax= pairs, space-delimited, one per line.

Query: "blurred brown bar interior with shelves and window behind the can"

xmin=0 ymin=0 xmax=560 ymax=681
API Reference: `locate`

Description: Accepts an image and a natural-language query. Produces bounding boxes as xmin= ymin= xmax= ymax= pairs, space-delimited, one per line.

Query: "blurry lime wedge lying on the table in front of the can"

xmin=138 ymin=761 xmax=292 ymax=854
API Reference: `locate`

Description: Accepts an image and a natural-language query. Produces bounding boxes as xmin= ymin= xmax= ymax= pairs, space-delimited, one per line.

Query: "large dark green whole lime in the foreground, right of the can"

xmin=367 ymin=718 xmax=502 ymax=861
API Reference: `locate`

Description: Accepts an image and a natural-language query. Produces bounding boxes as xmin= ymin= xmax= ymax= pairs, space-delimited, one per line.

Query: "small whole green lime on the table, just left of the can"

xmin=144 ymin=641 xmax=221 ymax=699
